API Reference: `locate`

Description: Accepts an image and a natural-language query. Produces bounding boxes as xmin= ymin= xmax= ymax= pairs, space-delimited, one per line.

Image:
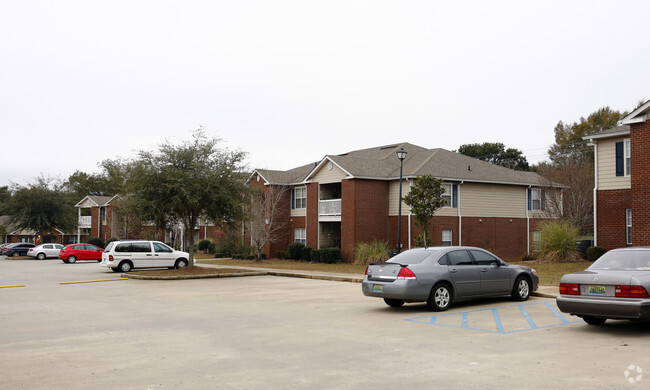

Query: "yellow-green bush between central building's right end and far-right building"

xmin=540 ymin=221 xmax=580 ymax=262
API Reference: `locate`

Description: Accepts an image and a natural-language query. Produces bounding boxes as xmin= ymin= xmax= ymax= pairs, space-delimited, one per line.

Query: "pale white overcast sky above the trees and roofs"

xmin=0 ymin=0 xmax=650 ymax=186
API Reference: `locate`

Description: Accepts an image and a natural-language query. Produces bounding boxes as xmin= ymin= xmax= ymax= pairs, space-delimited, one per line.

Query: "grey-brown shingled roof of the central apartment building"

xmin=257 ymin=143 xmax=545 ymax=185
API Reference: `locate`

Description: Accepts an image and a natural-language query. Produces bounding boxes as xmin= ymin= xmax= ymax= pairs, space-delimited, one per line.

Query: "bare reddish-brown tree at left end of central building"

xmin=249 ymin=185 xmax=291 ymax=260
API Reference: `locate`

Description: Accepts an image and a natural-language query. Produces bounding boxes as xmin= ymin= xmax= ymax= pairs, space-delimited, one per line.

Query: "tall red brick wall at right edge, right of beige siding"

xmin=628 ymin=121 xmax=650 ymax=246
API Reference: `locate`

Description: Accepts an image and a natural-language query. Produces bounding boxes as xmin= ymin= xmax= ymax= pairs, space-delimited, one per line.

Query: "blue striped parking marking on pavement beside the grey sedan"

xmin=404 ymin=302 xmax=582 ymax=334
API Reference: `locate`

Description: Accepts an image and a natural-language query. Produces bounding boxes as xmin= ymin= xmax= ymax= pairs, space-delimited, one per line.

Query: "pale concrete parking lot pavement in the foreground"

xmin=0 ymin=259 xmax=650 ymax=389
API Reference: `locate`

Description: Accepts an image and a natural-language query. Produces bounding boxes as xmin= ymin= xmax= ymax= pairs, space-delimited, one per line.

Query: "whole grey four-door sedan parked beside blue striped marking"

xmin=361 ymin=246 xmax=539 ymax=311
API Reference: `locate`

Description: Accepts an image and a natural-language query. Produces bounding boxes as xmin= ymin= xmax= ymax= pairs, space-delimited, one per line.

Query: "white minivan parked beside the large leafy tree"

xmin=101 ymin=240 xmax=190 ymax=272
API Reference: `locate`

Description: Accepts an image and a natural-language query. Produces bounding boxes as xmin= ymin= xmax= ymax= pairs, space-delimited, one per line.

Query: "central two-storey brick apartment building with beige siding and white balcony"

xmin=248 ymin=143 xmax=548 ymax=261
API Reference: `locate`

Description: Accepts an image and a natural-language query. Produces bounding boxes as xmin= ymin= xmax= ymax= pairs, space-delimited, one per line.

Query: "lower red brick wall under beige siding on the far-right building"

xmin=596 ymin=189 xmax=634 ymax=249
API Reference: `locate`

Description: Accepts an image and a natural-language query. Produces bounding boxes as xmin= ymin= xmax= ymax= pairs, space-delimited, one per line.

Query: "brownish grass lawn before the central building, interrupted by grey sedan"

xmin=197 ymin=256 xmax=591 ymax=286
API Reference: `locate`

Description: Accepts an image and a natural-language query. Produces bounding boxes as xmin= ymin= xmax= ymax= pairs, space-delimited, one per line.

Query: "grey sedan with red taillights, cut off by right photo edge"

xmin=556 ymin=247 xmax=650 ymax=325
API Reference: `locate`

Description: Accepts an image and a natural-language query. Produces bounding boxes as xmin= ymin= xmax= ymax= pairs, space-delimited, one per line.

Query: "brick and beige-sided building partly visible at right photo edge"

xmin=584 ymin=101 xmax=650 ymax=249
